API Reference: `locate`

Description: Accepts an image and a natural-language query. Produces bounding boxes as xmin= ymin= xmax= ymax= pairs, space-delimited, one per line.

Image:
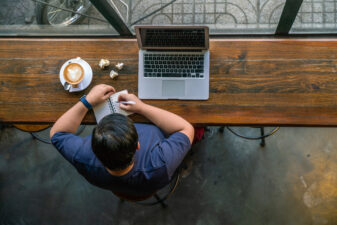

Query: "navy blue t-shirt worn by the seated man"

xmin=52 ymin=123 xmax=191 ymax=196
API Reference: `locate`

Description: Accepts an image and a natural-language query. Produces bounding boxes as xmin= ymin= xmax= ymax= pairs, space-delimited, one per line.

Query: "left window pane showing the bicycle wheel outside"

xmin=0 ymin=0 xmax=118 ymax=36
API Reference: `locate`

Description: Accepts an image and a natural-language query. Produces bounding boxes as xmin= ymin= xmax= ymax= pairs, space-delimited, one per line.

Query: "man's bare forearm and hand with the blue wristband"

xmin=50 ymin=84 xmax=115 ymax=138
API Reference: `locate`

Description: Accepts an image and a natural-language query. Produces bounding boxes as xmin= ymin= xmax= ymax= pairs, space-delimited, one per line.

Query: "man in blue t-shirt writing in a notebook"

xmin=50 ymin=84 xmax=194 ymax=198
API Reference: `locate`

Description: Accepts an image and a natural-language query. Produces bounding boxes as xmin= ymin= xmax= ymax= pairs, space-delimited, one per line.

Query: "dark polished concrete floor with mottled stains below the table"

xmin=0 ymin=127 xmax=337 ymax=225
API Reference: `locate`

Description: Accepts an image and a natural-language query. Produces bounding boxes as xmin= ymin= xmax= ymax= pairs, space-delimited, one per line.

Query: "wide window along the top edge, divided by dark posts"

xmin=0 ymin=0 xmax=337 ymax=36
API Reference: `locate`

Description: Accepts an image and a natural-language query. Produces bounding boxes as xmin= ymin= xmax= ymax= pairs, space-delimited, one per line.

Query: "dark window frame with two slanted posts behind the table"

xmin=0 ymin=0 xmax=336 ymax=38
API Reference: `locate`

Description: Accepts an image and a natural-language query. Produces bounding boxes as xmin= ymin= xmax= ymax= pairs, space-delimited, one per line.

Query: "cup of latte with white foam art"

xmin=63 ymin=62 xmax=85 ymax=88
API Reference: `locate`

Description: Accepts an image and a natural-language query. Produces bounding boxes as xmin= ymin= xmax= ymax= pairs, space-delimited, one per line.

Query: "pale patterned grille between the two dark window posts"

xmin=124 ymin=0 xmax=285 ymax=33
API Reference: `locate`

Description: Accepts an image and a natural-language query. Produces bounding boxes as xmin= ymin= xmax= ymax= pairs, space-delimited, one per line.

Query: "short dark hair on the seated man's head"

xmin=91 ymin=113 xmax=138 ymax=171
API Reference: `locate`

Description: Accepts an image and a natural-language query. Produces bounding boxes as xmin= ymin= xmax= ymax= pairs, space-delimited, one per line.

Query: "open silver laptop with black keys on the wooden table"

xmin=135 ymin=26 xmax=209 ymax=100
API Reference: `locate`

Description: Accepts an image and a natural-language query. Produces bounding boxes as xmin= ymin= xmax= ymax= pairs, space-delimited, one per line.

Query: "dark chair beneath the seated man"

xmin=113 ymin=168 xmax=181 ymax=208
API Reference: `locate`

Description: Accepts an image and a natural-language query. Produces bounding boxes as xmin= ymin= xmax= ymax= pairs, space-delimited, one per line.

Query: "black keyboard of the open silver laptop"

xmin=144 ymin=53 xmax=204 ymax=79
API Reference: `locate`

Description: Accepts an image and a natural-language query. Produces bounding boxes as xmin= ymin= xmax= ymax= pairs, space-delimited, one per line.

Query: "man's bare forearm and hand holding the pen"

xmin=119 ymin=94 xmax=194 ymax=143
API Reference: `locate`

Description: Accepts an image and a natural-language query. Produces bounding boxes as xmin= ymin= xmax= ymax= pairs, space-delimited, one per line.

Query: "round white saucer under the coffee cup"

xmin=59 ymin=57 xmax=92 ymax=92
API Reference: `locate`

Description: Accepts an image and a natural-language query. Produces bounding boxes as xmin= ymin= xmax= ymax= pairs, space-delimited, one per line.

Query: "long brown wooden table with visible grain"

xmin=0 ymin=38 xmax=337 ymax=126
